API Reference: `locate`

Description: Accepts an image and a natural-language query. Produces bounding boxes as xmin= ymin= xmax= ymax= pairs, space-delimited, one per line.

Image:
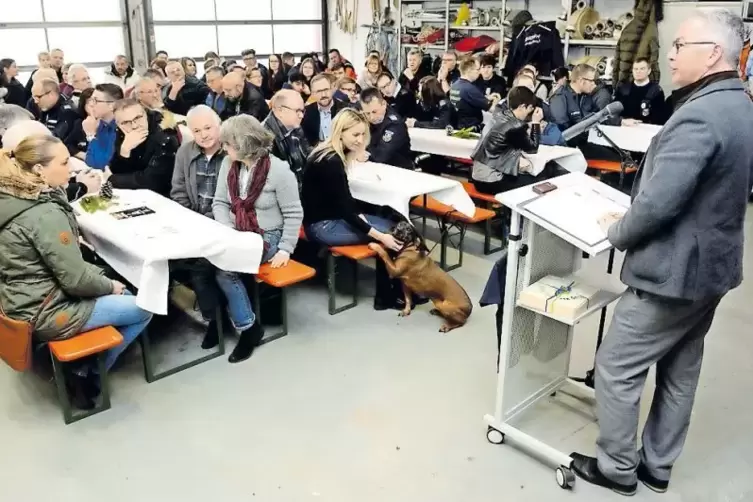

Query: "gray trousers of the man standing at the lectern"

xmin=596 ymin=288 xmax=721 ymax=484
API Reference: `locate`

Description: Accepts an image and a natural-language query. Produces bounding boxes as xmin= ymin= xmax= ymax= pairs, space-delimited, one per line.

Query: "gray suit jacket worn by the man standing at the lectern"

xmin=608 ymin=79 xmax=753 ymax=300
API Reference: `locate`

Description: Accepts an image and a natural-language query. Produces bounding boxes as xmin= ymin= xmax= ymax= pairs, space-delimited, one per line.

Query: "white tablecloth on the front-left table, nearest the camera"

xmin=74 ymin=190 xmax=264 ymax=315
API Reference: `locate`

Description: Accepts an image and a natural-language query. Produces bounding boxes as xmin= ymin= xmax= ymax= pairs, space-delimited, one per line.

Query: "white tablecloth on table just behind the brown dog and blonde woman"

xmin=348 ymin=162 xmax=476 ymax=218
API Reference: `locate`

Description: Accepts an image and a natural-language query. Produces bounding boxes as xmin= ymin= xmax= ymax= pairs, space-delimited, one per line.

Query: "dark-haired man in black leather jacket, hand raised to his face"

xmin=471 ymin=87 xmax=544 ymax=195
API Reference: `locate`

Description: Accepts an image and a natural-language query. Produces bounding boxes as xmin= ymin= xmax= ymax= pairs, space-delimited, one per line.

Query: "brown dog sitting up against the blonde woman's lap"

xmin=369 ymin=221 xmax=473 ymax=333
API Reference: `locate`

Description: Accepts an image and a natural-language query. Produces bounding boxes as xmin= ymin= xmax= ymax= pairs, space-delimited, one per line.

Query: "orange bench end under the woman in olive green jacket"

xmin=48 ymin=326 xmax=123 ymax=425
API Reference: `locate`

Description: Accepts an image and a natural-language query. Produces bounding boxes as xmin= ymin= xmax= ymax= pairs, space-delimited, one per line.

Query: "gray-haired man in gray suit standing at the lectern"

xmin=572 ymin=10 xmax=753 ymax=495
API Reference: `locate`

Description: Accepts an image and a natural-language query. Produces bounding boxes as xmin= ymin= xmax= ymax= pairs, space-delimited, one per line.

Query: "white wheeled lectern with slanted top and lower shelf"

xmin=485 ymin=173 xmax=630 ymax=488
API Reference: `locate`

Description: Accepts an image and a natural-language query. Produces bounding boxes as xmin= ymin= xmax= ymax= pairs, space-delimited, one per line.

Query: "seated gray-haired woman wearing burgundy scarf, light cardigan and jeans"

xmin=212 ymin=115 xmax=303 ymax=363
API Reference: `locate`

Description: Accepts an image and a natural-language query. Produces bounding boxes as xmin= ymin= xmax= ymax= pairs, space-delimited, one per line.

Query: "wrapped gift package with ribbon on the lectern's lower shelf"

xmin=518 ymin=275 xmax=598 ymax=319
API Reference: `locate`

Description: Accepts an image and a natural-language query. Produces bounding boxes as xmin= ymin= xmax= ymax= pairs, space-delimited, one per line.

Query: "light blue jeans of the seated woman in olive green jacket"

xmin=81 ymin=292 xmax=152 ymax=370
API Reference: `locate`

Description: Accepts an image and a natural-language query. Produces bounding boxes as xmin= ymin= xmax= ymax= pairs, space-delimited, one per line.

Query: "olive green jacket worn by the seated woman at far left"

xmin=0 ymin=172 xmax=112 ymax=341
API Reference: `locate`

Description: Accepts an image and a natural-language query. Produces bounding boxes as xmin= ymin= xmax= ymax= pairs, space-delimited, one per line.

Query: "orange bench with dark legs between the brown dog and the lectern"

xmin=411 ymin=195 xmax=496 ymax=271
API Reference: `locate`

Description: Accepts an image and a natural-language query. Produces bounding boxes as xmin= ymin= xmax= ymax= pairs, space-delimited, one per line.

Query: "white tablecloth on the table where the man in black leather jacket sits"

xmin=408 ymin=127 xmax=586 ymax=174
